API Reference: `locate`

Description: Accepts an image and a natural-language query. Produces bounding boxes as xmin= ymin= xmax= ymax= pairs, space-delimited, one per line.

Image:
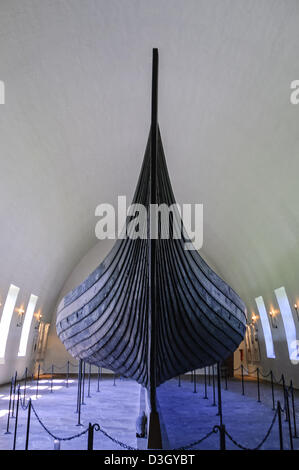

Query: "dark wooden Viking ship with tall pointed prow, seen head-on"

xmin=56 ymin=49 xmax=246 ymax=448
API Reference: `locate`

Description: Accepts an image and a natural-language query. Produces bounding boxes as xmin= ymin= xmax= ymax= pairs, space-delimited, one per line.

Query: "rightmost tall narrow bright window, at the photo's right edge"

xmin=274 ymin=287 xmax=299 ymax=361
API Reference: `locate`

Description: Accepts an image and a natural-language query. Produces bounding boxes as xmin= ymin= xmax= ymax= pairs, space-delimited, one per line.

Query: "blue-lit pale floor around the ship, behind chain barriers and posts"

xmin=0 ymin=375 xmax=299 ymax=450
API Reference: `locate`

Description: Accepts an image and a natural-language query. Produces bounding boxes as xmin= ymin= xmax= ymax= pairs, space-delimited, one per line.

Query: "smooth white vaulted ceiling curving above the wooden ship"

xmin=0 ymin=0 xmax=299 ymax=322
